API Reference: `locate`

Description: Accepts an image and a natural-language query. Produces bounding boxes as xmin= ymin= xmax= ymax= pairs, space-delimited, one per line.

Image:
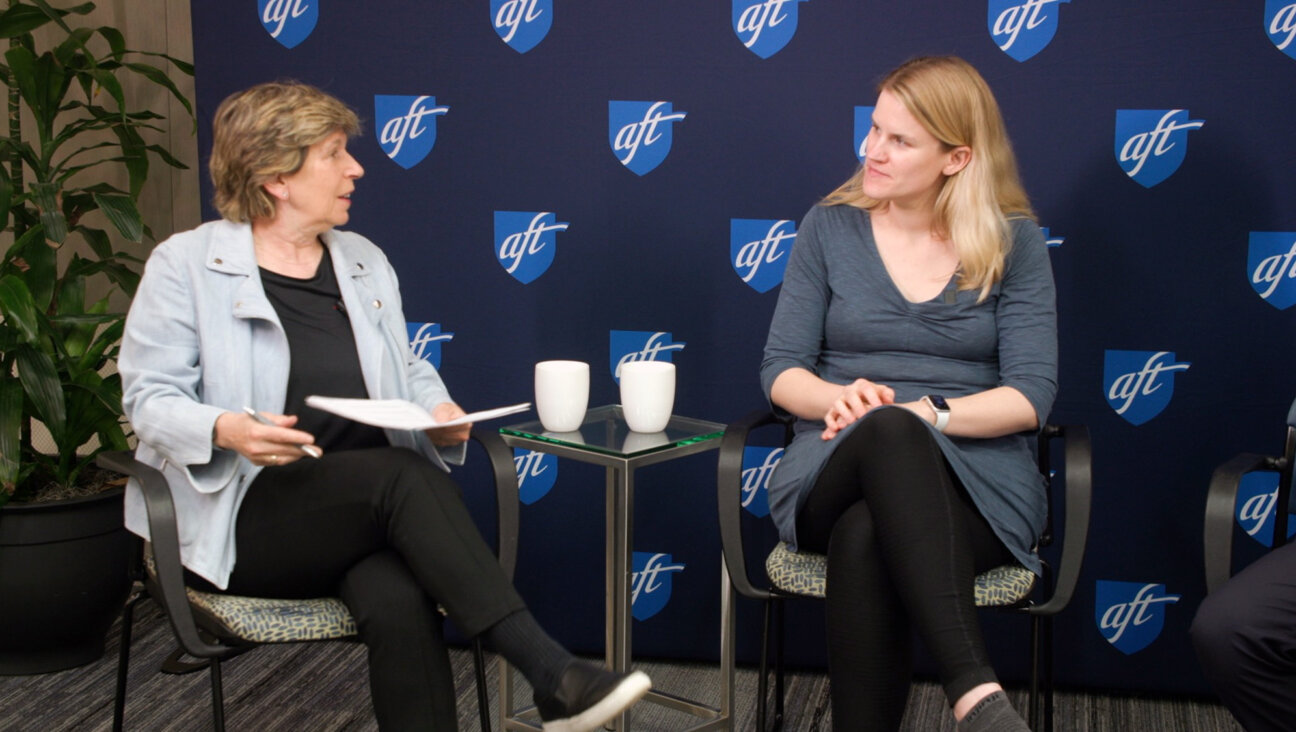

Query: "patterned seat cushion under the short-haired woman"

xmin=144 ymin=547 xmax=356 ymax=643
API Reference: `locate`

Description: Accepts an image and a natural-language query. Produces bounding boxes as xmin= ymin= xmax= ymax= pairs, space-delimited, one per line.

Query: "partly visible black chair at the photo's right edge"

xmin=1201 ymin=393 xmax=1296 ymax=595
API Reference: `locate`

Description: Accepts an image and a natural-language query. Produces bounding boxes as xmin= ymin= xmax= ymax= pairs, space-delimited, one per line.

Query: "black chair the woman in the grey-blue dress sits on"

xmin=717 ymin=411 xmax=1093 ymax=732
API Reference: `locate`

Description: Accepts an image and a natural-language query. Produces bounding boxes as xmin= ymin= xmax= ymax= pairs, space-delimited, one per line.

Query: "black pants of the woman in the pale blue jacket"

xmin=229 ymin=447 xmax=524 ymax=729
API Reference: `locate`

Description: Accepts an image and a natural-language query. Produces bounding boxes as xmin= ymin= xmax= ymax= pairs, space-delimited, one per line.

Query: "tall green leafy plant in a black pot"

xmin=0 ymin=0 xmax=193 ymax=674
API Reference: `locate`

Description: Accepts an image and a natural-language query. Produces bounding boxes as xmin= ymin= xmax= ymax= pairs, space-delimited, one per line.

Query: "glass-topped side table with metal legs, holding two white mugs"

xmin=499 ymin=404 xmax=734 ymax=731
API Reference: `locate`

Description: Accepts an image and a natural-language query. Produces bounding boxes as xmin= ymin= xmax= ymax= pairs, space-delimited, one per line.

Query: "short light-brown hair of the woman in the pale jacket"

xmin=209 ymin=82 xmax=360 ymax=222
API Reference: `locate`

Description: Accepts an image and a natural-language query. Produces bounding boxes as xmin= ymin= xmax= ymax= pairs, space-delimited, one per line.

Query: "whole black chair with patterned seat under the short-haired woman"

xmin=97 ymin=429 xmax=518 ymax=732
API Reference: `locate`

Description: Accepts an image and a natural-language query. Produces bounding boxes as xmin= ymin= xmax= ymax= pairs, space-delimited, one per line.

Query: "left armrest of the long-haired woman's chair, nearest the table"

xmin=715 ymin=409 xmax=781 ymax=600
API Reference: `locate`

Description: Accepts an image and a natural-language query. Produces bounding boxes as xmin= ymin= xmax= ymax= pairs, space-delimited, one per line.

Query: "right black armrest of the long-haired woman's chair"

xmin=1029 ymin=425 xmax=1094 ymax=615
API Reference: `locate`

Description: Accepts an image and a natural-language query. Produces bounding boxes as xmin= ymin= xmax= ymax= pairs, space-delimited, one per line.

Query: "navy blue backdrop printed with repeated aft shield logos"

xmin=193 ymin=0 xmax=1296 ymax=692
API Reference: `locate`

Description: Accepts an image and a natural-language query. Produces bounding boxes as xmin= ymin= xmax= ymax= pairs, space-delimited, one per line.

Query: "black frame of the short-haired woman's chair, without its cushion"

xmin=97 ymin=428 xmax=520 ymax=732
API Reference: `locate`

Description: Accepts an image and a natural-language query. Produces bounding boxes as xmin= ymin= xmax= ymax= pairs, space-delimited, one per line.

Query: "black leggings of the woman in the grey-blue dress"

xmin=797 ymin=408 xmax=1011 ymax=729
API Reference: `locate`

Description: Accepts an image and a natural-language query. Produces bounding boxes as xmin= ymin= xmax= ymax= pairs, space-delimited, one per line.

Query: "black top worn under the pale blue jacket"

xmin=260 ymin=250 xmax=389 ymax=451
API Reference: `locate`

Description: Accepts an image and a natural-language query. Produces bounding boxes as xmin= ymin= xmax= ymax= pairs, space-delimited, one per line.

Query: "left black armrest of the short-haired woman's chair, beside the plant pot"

xmin=95 ymin=452 xmax=238 ymax=658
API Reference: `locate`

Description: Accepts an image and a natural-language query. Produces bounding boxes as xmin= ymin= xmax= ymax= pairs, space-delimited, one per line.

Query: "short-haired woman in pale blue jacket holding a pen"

xmin=119 ymin=83 xmax=651 ymax=731
